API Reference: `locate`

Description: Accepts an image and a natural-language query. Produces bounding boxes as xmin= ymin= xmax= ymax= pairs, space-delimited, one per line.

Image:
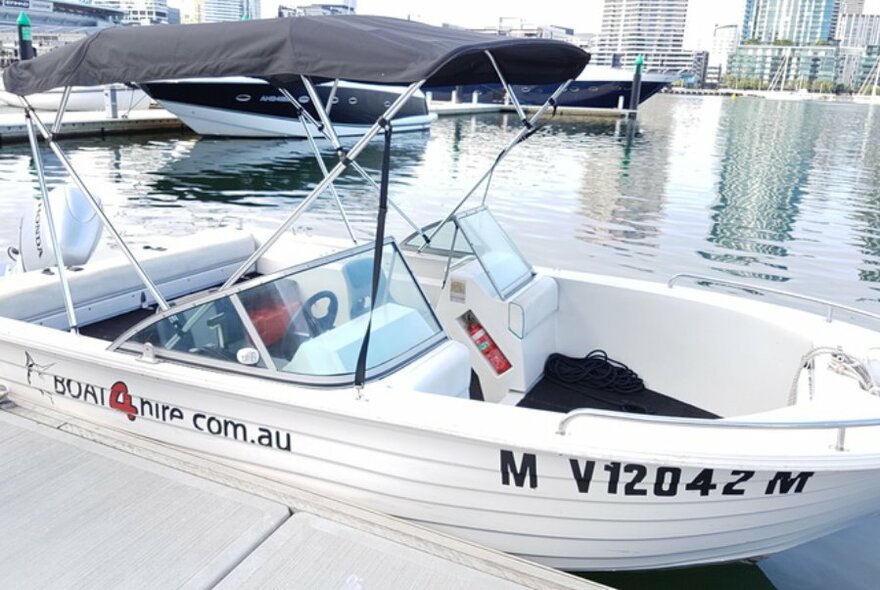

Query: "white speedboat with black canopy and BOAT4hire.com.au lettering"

xmin=0 ymin=16 xmax=880 ymax=570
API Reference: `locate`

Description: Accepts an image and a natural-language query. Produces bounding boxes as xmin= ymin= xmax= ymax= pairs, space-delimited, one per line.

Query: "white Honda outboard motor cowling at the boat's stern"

xmin=18 ymin=185 xmax=102 ymax=271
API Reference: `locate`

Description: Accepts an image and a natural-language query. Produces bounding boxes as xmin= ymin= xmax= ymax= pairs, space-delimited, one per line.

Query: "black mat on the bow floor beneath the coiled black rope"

xmin=517 ymin=376 xmax=721 ymax=418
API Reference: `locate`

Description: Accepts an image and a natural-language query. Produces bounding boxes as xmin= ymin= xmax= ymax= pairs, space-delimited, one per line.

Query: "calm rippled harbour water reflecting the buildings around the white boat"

xmin=0 ymin=96 xmax=880 ymax=588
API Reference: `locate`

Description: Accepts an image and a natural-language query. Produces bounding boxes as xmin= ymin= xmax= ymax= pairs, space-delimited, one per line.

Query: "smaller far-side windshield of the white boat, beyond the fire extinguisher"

xmin=403 ymin=207 xmax=534 ymax=299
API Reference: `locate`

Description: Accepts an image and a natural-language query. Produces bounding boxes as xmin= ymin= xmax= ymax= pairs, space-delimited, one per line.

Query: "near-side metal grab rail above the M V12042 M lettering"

xmin=556 ymin=409 xmax=880 ymax=451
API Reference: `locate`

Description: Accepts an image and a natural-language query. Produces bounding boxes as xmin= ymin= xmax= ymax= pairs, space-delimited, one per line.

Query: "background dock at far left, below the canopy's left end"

xmin=0 ymin=109 xmax=189 ymax=146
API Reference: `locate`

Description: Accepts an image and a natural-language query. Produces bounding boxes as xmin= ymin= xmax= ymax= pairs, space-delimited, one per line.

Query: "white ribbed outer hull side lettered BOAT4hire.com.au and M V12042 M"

xmin=6 ymin=320 xmax=880 ymax=571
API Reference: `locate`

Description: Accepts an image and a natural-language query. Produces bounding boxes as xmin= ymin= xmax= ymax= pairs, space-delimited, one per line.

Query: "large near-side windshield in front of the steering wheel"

xmin=119 ymin=241 xmax=445 ymax=384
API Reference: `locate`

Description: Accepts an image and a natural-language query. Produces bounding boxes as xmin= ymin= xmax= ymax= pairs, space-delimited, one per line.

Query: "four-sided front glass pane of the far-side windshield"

xmin=457 ymin=209 xmax=532 ymax=299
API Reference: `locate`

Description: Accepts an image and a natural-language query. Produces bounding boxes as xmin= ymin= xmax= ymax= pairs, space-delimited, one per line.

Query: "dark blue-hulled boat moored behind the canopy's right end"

xmin=431 ymin=66 xmax=676 ymax=109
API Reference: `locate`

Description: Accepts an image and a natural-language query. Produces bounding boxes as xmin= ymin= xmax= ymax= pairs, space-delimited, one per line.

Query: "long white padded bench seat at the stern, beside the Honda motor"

xmin=0 ymin=230 xmax=255 ymax=329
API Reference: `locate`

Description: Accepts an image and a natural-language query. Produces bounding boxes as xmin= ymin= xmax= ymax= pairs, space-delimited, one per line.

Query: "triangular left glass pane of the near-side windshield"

xmin=131 ymin=297 xmax=264 ymax=367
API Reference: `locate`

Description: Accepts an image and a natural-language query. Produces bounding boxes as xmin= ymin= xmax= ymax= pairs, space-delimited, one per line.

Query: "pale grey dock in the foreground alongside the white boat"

xmin=0 ymin=398 xmax=605 ymax=590
